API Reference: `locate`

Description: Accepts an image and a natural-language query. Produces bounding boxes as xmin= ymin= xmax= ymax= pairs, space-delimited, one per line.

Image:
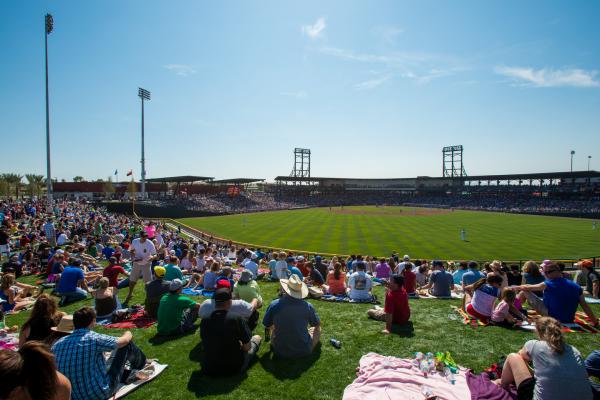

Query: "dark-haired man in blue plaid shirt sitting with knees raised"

xmin=52 ymin=307 xmax=146 ymax=400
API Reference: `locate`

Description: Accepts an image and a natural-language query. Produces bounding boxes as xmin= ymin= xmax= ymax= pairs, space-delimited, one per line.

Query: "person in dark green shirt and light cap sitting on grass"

xmin=157 ymin=279 xmax=200 ymax=335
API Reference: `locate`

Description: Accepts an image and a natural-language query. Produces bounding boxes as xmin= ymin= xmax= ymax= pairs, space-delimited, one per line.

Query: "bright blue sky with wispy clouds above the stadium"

xmin=0 ymin=0 xmax=600 ymax=180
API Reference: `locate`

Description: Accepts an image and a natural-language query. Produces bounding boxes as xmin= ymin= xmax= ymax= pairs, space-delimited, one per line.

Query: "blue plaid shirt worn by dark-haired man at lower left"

xmin=52 ymin=329 xmax=117 ymax=400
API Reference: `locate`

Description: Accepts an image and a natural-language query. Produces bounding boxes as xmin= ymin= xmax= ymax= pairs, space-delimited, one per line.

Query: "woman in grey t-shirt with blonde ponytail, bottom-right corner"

xmin=495 ymin=317 xmax=592 ymax=400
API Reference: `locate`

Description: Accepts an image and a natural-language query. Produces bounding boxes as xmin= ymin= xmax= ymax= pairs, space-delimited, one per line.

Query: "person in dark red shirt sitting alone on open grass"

xmin=367 ymin=275 xmax=410 ymax=335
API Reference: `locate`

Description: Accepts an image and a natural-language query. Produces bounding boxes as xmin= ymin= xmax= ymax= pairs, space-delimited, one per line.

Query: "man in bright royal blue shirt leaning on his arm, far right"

xmin=516 ymin=263 xmax=599 ymax=326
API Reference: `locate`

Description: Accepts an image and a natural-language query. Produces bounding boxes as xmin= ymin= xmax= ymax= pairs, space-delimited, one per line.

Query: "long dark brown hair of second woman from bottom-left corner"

xmin=19 ymin=341 xmax=57 ymax=400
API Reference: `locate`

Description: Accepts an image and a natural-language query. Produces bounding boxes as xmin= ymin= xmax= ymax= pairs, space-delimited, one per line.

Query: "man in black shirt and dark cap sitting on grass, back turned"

xmin=200 ymin=288 xmax=261 ymax=376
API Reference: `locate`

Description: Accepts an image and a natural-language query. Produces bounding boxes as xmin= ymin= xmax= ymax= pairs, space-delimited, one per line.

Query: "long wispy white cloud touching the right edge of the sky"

xmin=494 ymin=67 xmax=600 ymax=87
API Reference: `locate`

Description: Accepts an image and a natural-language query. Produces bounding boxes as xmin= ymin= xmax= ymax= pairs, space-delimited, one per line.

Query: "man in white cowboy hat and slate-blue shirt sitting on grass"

xmin=263 ymin=275 xmax=321 ymax=358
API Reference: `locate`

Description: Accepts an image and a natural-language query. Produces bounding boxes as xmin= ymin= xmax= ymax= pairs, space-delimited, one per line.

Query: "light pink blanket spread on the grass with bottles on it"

xmin=343 ymin=353 xmax=471 ymax=400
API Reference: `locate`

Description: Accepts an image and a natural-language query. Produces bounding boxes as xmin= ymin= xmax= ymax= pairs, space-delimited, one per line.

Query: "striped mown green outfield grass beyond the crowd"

xmin=179 ymin=207 xmax=600 ymax=260
